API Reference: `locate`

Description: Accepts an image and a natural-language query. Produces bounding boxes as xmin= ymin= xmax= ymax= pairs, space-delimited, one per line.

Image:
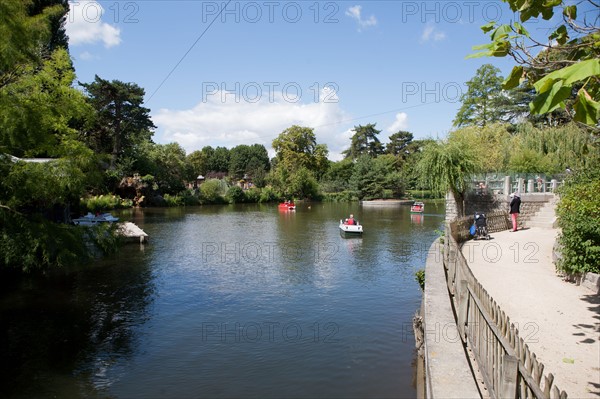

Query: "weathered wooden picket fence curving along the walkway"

xmin=444 ymin=219 xmax=567 ymax=399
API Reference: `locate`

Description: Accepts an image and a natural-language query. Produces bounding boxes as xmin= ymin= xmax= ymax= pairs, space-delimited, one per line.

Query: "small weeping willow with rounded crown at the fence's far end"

xmin=417 ymin=140 xmax=480 ymax=217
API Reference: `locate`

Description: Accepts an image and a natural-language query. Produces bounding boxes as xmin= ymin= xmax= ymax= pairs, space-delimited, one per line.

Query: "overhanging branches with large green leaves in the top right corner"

xmin=469 ymin=0 xmax=600 ymax=127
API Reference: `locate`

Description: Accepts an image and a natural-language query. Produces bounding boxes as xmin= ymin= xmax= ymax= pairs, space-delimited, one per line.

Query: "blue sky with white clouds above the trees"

xmin=67 ymin=0 xmax=568 ymax=160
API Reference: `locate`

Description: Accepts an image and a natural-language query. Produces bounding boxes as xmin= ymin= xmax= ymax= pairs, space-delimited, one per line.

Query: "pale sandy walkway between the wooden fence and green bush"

xmin=462 ymin=227 xmax=600 ymax=399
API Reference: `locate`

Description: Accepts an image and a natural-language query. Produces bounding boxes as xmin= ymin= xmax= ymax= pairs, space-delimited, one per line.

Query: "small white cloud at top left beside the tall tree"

xmin=65 ymin=0 xmax=121 ymax=48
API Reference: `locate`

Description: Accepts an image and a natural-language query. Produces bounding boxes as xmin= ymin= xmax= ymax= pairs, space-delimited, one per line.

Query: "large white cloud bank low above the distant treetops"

xmin=152 ymin=89 xmax=352 ymax=160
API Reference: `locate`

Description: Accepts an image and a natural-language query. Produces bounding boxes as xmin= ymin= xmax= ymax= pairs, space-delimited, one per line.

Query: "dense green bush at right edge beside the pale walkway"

xmin=557 ymin=172 xmax=600 ymax=274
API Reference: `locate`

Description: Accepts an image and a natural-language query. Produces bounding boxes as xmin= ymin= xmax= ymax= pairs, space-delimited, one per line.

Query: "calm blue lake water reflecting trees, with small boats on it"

xmin=0 ymin=203 xmax=444 ymax=398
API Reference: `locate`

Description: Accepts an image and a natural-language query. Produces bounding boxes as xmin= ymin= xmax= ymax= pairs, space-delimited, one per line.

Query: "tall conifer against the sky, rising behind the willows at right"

xmin=453 ymin=64 xmax=506 ymax=127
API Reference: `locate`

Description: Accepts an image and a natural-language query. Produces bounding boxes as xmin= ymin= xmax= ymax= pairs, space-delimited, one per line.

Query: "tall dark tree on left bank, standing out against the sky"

xmin=80 ymin=75 xmax=156 ymax=170
